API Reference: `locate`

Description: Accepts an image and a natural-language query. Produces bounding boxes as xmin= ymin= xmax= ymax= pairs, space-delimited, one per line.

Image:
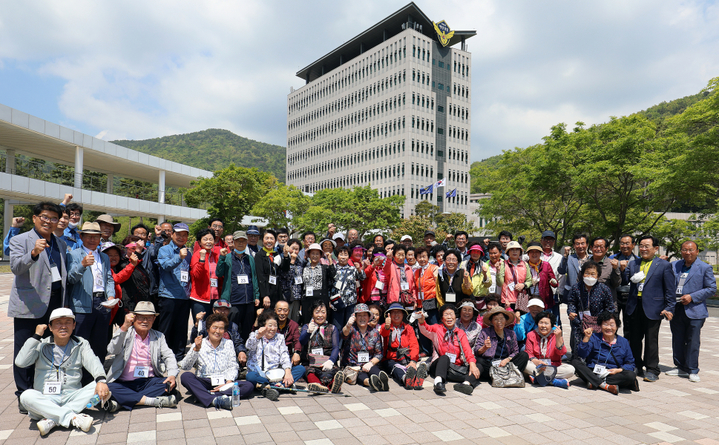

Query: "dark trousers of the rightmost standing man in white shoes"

xmin=669 ymin=303 xmax=704 ymax=374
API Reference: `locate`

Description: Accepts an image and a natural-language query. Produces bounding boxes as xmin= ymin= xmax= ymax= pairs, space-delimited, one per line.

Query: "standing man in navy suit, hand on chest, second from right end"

xmin=626 ymin=235 xmax=676 ymax=382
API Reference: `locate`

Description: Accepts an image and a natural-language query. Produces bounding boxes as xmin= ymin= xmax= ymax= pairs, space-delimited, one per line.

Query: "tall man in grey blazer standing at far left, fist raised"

xmin=8 ymin=202 xmax=67 ymax=413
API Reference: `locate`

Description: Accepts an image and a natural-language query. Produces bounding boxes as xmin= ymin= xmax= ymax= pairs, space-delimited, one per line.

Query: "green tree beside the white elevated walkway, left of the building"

xmin=185 ymin=164 xmax=277 ymax=233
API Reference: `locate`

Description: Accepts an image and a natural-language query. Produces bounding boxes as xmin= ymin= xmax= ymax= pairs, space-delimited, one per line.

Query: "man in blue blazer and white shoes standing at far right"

xmin=666 ymin=241 xmax=717 ymax=382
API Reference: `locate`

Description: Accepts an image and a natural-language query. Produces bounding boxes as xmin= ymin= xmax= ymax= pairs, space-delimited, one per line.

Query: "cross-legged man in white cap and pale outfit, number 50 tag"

xmin=15 ymin=308 xmax=110 ymax=436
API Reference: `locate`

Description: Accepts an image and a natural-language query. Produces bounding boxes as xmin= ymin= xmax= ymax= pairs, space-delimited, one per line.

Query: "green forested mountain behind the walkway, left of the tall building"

xmin=112 ymin=128 xmax=285 ymax=181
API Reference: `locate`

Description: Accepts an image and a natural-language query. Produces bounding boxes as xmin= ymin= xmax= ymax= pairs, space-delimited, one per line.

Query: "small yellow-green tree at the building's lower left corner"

xmin=252 ymin=184 xmax=312 ymax=232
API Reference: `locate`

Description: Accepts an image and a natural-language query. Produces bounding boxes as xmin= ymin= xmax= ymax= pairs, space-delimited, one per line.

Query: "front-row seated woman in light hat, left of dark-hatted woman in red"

xmin=342 ymin=303 xmax=389 ymax=391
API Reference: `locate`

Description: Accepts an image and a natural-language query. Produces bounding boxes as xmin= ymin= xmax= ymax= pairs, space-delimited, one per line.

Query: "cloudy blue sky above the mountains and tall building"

xmin=0 ymin=0 xmax=719 ymax=161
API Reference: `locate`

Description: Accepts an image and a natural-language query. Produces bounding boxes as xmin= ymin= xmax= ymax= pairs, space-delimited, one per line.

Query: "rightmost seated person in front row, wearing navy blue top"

xmin=572 ymin=311 xmax=639 ymax=395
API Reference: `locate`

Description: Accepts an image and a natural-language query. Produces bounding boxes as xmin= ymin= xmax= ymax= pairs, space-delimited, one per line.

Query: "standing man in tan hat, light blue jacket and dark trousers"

xmin=67 ymin=222 xmax=117 ymax=363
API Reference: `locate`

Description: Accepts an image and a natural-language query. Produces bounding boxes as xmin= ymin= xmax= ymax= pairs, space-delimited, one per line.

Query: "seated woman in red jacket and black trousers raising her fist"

xmin=415 ymin=303 xmax=480 ymax=395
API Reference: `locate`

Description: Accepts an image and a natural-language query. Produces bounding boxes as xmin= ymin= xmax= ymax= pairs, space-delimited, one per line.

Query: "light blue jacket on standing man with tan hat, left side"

xmin=67 ymin=247 xmax=115 ymax=314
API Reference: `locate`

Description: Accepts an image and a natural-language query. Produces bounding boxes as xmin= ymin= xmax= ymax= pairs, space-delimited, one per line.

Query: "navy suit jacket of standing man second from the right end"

xmin=626 ymin=258 xmax=677 ymax=320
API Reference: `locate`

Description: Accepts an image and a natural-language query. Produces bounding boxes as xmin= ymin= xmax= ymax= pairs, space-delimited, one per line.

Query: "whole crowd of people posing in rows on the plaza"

xmin=4 ymin=196 xmax=716 ymax=435
